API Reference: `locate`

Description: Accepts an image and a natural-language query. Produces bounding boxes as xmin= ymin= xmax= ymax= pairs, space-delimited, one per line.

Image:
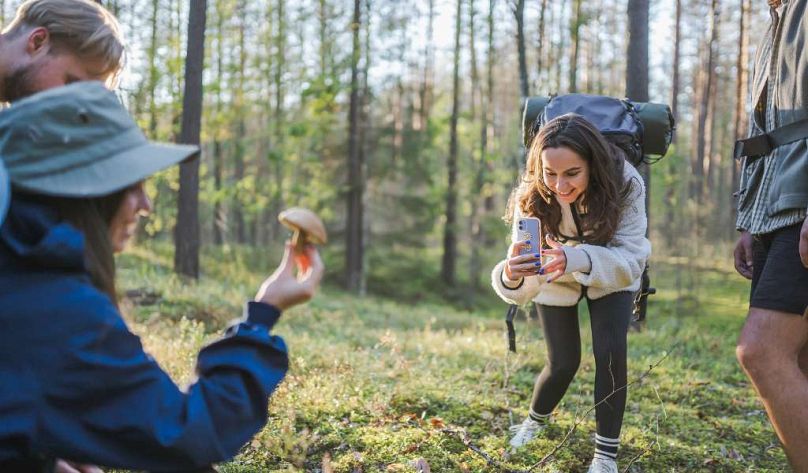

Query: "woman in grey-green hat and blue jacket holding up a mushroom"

xmin=0 ymin=82 xmax=323 ymax=472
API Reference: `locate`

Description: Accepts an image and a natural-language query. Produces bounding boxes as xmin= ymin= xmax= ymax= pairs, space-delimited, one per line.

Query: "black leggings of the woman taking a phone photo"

xmin=531 ymin=292 xmax=634 ymax=438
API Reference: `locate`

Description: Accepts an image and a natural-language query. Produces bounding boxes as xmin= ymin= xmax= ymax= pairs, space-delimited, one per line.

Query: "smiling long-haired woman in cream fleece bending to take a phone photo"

xmin=491 ymin=114 xmax=651 ymax=473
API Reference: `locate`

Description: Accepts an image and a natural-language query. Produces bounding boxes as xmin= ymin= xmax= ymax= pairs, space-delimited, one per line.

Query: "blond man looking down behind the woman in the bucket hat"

xmin=0 ymin=0 xmax=124 ymax=102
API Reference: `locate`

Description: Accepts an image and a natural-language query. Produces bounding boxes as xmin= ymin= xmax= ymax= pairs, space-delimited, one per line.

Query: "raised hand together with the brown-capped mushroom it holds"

xmin=255 ymin=208 xmax=328 ymax=310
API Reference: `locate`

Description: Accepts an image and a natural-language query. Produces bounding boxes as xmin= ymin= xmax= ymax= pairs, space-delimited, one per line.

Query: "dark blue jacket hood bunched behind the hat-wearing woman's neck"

xmin=0 ymin=195 xmax=86 ymax=271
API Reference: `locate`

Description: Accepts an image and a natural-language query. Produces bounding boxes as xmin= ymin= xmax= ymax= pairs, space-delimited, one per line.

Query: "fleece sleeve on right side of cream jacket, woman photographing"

xmin=572 ymin=174 xmax=651 ymax=288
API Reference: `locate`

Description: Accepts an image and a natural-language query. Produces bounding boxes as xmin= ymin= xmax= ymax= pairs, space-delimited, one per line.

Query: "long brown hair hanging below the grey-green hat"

xmin=25 ymin=189 xmax=127 ymax=307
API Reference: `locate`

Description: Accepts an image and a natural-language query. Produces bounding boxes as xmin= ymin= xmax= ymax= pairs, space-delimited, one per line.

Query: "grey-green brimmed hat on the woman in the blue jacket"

xmin=0 ymin=82 xmax=199 ymax=197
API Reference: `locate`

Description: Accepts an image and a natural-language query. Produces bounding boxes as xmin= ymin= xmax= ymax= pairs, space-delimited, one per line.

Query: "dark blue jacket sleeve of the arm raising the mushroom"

xmin=36 ymin=286 xmax=288 ymax=471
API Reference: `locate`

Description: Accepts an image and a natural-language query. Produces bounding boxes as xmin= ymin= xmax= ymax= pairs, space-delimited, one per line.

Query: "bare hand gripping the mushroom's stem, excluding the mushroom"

xmin=255 ymin=242 xmax=325 ymax=310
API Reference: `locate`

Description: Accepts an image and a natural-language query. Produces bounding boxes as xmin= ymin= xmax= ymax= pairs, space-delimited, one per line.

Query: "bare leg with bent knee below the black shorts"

xmin=736 ymin=307 xmax=808 ymax=473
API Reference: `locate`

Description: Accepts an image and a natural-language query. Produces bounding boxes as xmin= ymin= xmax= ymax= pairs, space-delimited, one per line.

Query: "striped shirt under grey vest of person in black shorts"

xmin=736 ymin=2 xmax=808 ymax=235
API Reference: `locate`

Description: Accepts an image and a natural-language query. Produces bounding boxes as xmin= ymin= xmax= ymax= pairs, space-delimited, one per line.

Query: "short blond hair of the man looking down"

xmin=5 ymin=0 xmax=125 ymax=83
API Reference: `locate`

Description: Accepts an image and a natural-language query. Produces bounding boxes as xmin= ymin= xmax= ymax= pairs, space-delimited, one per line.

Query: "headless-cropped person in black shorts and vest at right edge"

xmin=734 ymin=0 xmax=808 ymax=472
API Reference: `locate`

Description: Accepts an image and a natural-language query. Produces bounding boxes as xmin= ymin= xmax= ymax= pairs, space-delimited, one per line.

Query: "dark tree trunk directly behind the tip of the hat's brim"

xmin=174 ymin=0 xmax=207 ymax=279
